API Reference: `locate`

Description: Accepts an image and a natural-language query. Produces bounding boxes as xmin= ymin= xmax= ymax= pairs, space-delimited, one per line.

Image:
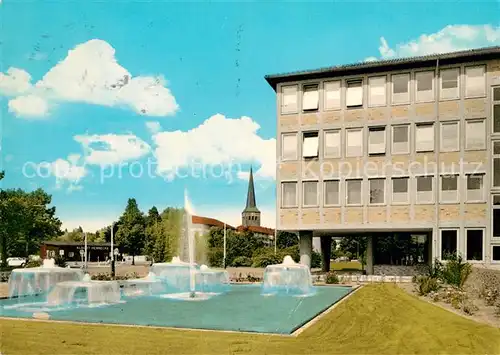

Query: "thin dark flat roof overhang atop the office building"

xmin=264 ymin=46 xmax=500 ymax=91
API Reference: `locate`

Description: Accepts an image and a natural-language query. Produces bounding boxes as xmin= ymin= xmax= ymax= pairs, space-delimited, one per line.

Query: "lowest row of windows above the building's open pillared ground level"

xmin=281 ymin=174 xmax=485 ymax=208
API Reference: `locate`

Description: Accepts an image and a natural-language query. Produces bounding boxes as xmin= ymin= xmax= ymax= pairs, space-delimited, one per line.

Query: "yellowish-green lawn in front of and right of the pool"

xmin=0 ymin=284 xmax=500 ymax=355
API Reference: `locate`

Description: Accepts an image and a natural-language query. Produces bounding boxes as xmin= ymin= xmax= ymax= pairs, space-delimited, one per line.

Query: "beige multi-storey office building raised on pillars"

xmin=266 ymin=47 xmax=500 ymax=273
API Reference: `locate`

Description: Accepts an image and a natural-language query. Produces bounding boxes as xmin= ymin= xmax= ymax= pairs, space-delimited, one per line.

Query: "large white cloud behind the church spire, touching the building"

xmin=153 ymin=114 xmax=276 ymax=178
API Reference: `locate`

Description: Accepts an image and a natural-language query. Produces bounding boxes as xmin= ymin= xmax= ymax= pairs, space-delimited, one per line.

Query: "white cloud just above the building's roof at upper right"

xmin=370 ymin=25 xmax=500 ymax=59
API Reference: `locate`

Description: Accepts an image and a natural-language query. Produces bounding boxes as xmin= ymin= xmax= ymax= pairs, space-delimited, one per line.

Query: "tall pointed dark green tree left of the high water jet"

xmin=116 ymin=198 xmax=145 ymax=265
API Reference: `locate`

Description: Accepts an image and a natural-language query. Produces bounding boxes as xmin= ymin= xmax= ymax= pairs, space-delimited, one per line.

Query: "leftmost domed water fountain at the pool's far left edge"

xmin=9 ymin=259 xmax=83 ymax=297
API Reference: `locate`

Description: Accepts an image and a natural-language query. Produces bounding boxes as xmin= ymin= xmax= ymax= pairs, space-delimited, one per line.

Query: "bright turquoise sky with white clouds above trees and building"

xmin=0 ymin=0 xmax=500 ymax=232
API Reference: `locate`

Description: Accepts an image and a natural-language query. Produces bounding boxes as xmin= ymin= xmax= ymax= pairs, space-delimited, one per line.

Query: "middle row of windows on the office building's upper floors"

xmin=281 ymin=119 xmax=486 ymax=161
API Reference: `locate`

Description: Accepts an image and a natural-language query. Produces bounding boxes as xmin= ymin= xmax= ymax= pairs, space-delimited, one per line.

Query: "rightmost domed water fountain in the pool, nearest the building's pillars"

xmin=262 ymin=255 xmax=315 ymax=296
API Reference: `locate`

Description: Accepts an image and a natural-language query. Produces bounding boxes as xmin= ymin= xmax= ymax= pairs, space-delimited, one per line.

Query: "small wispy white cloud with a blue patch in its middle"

xmin=74 ymin=134 xmax=151 ymax=165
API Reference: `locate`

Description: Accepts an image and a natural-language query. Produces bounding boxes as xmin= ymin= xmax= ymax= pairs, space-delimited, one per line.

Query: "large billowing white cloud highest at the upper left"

xmin=0 ymin=39 xmax=179 ymax=116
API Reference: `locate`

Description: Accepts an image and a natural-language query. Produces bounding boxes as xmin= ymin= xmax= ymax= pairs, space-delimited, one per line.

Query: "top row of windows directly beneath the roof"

xmin=281 ymin=65 xmax=486 ymax=114
